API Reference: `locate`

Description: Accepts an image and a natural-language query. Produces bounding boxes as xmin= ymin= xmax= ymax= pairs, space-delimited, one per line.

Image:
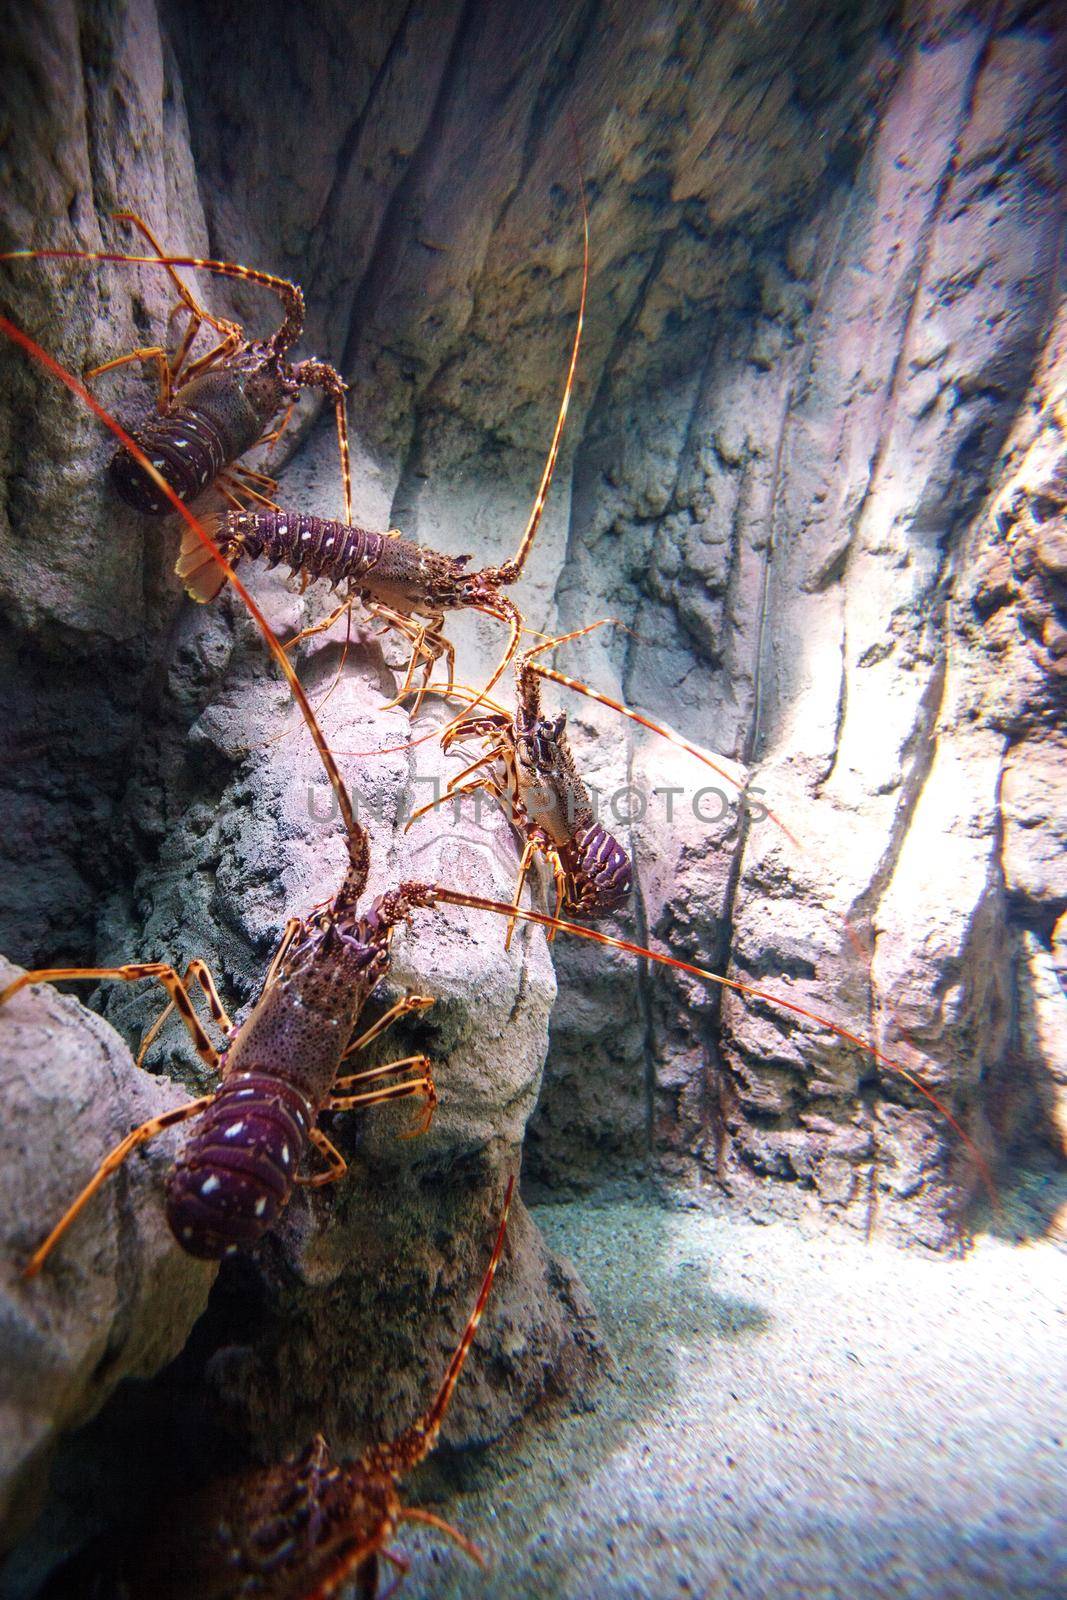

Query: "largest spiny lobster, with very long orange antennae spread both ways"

xmin=0 ymin=317 xmax=995 ymax=1272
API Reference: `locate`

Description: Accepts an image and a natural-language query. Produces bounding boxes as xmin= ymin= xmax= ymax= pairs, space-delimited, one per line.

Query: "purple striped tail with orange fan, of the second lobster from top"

xmin=174 ymin=510 xmax=386 ymax=600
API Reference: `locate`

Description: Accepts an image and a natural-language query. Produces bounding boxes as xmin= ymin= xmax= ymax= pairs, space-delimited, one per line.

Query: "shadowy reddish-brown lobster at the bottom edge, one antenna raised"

xmin=123 ymin=1178 xmax=515 ymax=1600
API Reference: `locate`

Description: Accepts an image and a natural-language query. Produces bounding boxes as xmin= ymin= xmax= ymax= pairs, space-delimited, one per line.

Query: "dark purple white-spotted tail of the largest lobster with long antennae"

xmin=166 ymin=1072 xmax=315 ymax=1261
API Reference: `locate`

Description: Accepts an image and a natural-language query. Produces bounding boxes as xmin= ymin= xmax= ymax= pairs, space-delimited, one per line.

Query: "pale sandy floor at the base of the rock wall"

xmin=397 ymin=1202 xmax=1067 ymax=1600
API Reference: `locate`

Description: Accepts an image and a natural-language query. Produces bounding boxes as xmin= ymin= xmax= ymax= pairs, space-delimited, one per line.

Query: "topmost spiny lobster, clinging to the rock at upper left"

xmin=0 ymin=211 xmax=352 ymax=522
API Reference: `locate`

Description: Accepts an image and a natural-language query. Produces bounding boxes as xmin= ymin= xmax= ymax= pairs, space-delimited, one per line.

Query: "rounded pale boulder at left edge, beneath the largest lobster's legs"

xmin=0 ymin=958 xmax=216 ymax=1549
